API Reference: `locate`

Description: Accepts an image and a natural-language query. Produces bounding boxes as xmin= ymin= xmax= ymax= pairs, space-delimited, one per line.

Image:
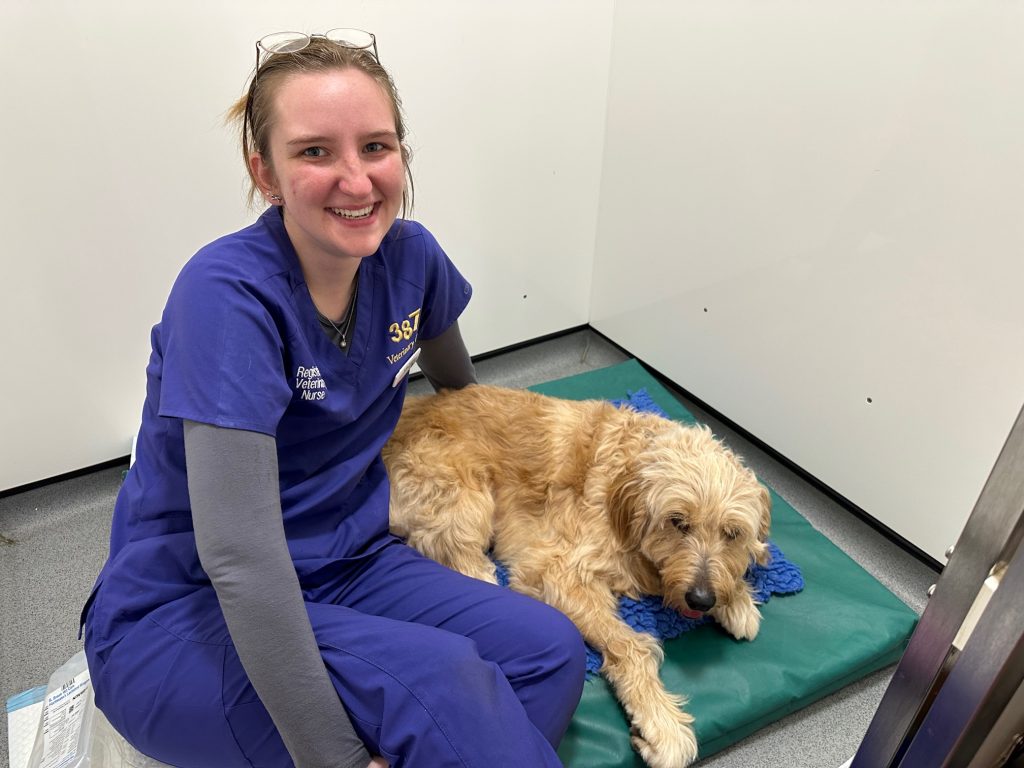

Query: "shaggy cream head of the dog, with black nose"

xmin=607 ymin=415 xmax=771 ymax=616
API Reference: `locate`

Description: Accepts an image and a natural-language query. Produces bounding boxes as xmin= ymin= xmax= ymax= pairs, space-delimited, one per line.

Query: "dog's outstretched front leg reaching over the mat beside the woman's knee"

xmin=544 ymin=577 xmax=697 ymax=768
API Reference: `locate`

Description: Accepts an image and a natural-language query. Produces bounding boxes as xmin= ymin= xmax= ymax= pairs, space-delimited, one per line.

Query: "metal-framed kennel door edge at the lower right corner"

xmin=852 ymin=410 xmax=1024 ymax=768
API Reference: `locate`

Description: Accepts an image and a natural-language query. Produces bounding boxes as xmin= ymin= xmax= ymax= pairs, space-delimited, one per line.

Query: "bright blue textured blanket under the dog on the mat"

xmin=496 ymin=389 xmax=804 ymax=676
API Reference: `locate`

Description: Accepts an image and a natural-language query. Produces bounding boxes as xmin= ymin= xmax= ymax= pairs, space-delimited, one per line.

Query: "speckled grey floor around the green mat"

xmin=0 ymin=331 xmax=938 ymax=768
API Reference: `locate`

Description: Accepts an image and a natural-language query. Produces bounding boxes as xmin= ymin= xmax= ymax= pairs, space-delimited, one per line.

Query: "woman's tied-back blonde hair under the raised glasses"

xmin=226 ymin=37 xmax=415 ymax=218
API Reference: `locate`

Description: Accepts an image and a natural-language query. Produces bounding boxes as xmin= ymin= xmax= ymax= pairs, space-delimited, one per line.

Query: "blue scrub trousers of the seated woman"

xmin=86 ymin=543 xmax=586 ymax=768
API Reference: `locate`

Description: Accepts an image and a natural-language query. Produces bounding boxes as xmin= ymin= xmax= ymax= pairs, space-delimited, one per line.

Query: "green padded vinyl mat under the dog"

xmin=531 ymin=360 xmax=918 ymax=768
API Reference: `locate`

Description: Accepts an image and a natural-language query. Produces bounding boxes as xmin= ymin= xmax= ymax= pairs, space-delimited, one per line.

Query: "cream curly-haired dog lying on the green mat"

xmin=384 ymin=385 xmax=770 ymax=768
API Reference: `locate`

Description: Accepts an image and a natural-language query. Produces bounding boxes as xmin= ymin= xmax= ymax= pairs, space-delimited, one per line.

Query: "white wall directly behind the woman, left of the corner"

xmin=0 ymin=0 xmax=612 ymax=490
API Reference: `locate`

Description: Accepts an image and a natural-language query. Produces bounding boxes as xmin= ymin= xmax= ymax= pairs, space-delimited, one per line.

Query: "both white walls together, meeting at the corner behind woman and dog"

xmin=6 ymin=0 xmax=1024 ymax=556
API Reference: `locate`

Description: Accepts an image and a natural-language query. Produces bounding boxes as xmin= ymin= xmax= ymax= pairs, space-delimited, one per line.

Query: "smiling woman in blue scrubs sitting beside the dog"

xmin=83 ymin=30 xmax=585 ymax=768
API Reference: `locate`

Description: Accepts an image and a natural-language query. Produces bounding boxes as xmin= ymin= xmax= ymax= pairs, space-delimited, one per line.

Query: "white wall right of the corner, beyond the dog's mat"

xmin=591 ymin=0 xmax=1024 ymax=558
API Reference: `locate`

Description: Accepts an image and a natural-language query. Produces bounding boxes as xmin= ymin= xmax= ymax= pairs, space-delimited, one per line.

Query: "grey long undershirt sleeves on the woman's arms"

xmin=184 ymin=324 xmax=475 ymax=768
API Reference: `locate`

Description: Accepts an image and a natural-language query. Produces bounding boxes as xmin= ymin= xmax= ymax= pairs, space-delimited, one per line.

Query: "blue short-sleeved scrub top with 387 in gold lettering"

xmin=83 ymin=208 xmax=472 ymax=646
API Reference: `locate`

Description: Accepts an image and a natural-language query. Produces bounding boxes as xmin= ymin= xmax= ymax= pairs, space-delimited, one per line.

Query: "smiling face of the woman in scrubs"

xmin=250 ymin=69 xmax=406 ymax=268
